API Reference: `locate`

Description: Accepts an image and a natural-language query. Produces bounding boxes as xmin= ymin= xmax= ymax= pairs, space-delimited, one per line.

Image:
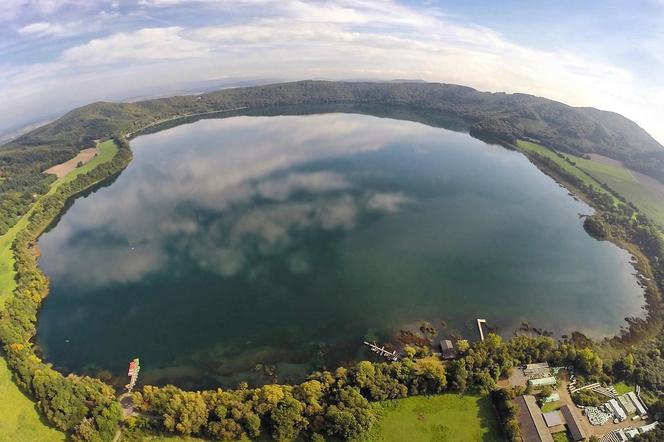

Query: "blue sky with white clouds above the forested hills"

xmin=0 ymin=0 xmax=664 ymax=143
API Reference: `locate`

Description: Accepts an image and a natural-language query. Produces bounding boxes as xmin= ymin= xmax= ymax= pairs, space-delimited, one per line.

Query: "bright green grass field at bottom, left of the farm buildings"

xmin=367 ymin=393 xmax=503 ymax=442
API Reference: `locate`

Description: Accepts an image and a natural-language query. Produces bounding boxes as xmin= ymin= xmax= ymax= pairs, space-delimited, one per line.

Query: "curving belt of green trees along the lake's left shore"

xmin=0 ymin=139 xmax=131 ymax=441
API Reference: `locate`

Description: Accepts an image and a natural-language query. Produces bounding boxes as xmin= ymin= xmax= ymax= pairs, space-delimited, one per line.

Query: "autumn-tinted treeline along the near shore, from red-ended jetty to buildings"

xmin=128 ymin=334 xmax=607 ymax=440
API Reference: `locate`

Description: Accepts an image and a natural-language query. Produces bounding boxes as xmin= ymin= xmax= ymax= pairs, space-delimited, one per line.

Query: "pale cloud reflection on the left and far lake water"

xmin=40 ymin=114 xmax=420 ymax=288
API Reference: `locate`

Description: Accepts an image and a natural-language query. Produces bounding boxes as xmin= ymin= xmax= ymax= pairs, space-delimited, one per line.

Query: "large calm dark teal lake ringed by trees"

xmin=38 ymin=113 xmax=643 ymax=386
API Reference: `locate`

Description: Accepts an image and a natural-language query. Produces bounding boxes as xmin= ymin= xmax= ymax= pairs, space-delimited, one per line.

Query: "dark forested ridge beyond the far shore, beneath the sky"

xmin=0 ymin=81 xmax=664 ymax=182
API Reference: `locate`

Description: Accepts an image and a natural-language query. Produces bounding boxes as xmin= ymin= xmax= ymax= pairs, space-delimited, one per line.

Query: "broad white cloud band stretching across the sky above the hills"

xmin=0 ymin=0 xmax=664 ymax=140
